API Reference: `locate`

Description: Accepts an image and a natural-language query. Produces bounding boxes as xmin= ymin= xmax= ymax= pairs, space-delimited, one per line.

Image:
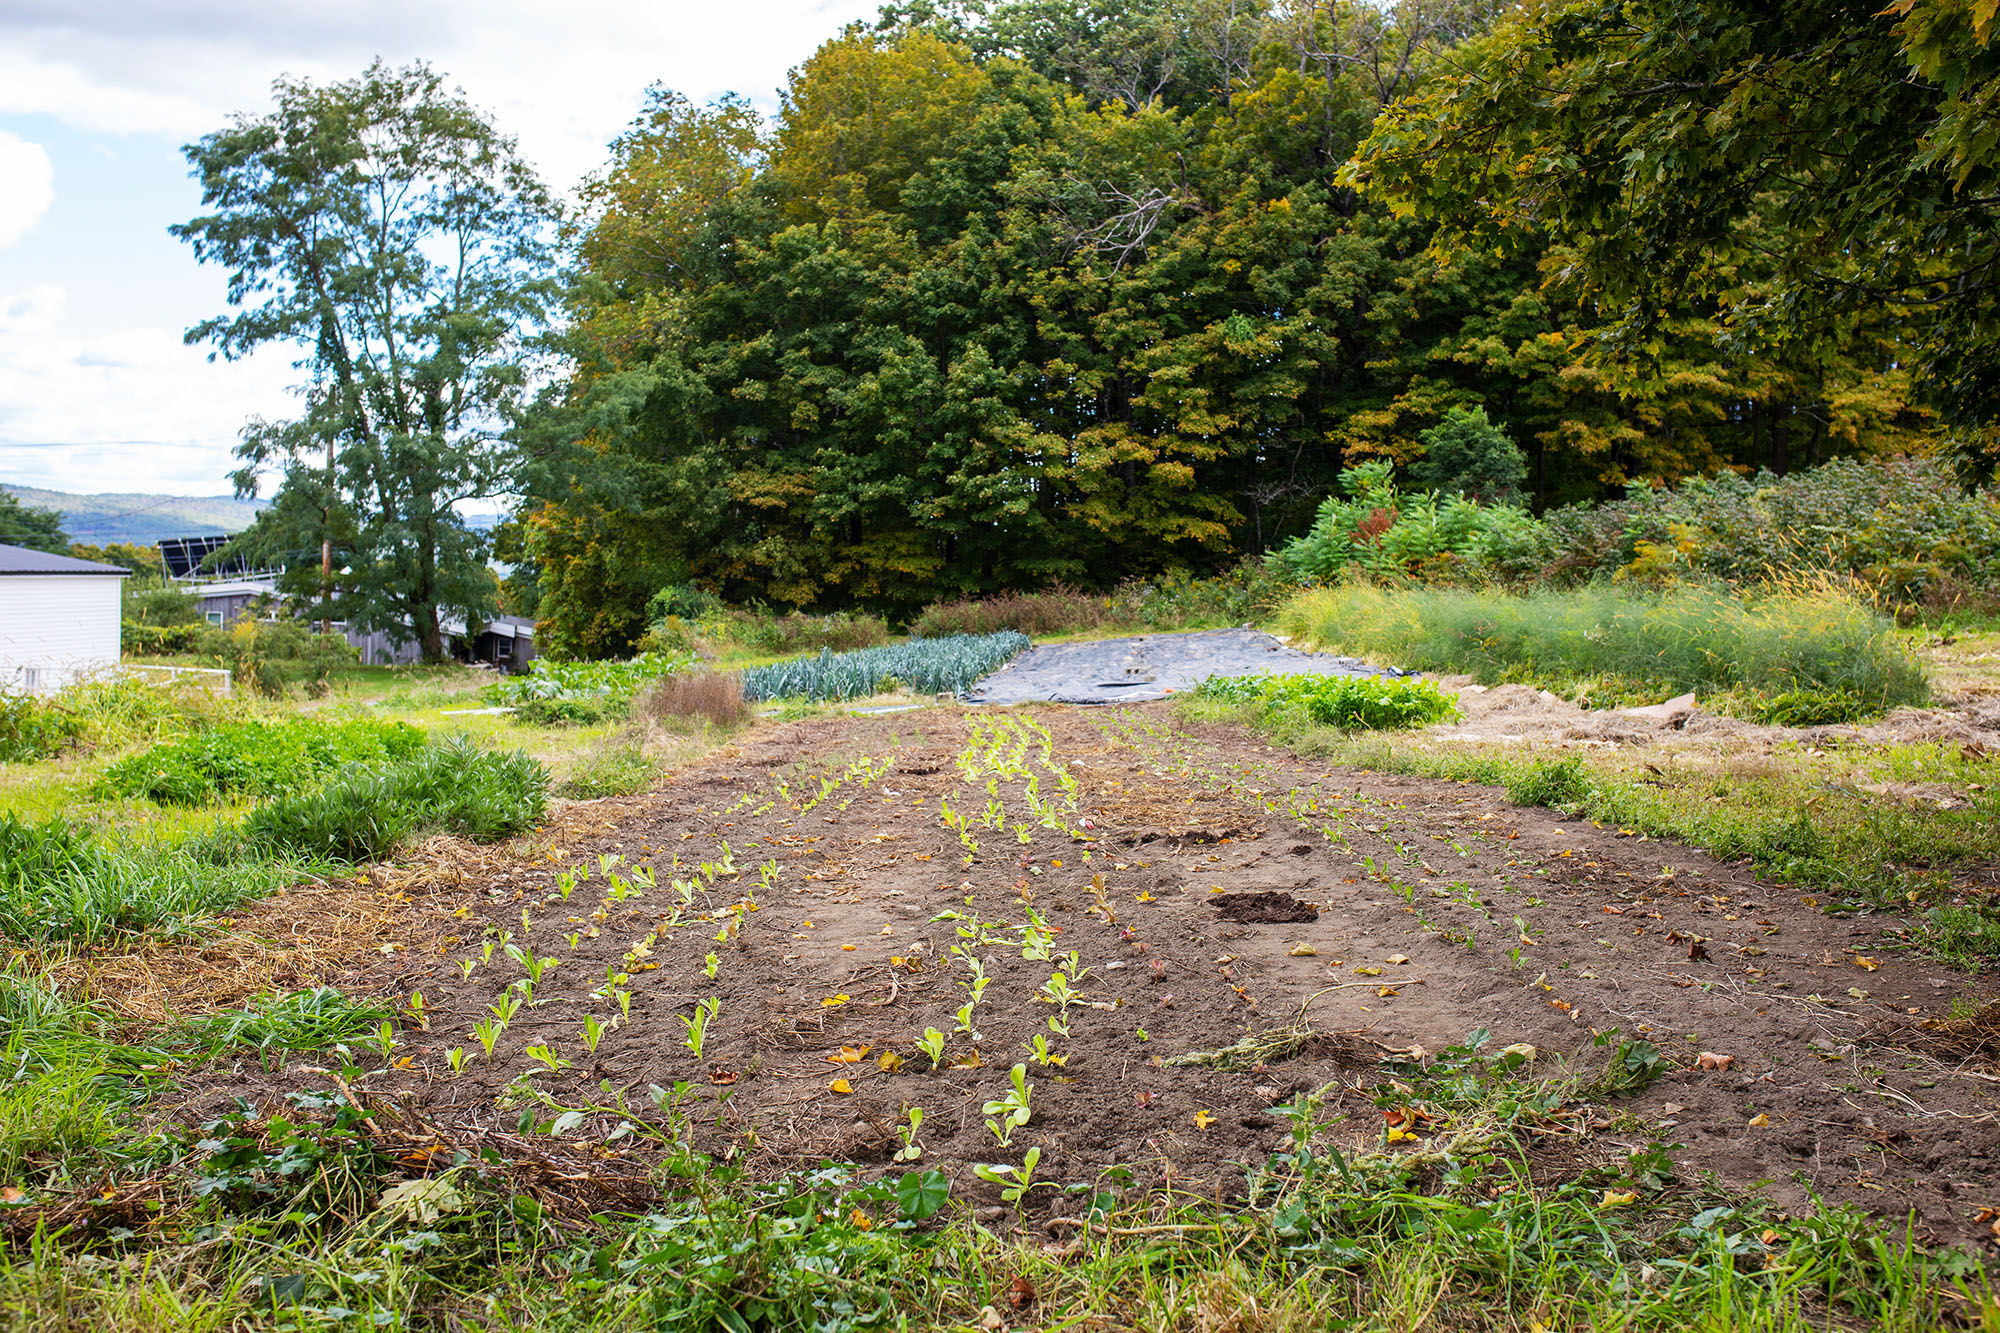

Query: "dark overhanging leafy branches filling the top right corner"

xmin=1350 ymin=0 xmax=2000 ymax=474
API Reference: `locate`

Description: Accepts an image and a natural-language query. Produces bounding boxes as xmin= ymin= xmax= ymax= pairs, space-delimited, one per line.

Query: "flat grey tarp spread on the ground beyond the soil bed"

xmin=966 ymin=628 xmax=1404 ymax=705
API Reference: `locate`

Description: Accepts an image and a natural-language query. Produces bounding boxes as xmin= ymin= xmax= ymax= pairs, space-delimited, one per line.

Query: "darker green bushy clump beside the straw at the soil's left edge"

xmin=244 ymin=737 xmax=548 ymax=861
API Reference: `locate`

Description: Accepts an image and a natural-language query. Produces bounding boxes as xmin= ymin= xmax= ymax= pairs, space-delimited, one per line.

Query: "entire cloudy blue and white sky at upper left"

xmin=0 ymin=0 xmax=880 ymax=494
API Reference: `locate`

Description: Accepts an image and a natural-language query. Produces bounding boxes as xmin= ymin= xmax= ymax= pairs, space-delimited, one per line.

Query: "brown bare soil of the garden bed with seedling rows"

xmin=164 ymin=705 xmax=2000 ymax=1241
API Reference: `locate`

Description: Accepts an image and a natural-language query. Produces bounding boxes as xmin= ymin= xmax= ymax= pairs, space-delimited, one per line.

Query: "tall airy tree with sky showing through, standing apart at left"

xmin=172 ymin=62 xmax=556 ymax=660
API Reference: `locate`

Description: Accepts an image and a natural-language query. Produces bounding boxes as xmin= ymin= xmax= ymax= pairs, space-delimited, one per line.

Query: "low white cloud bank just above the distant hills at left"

xmin=0 ymin=284 xmax=292 ymax=494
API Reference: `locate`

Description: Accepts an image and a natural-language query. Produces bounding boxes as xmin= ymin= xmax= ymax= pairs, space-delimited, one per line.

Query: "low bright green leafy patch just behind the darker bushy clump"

xmin=96 ymin=719 xmax=424 ymax=805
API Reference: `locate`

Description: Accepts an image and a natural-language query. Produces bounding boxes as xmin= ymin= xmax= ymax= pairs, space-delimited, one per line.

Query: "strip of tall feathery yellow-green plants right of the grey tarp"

xmin=1278 ymin=582 xmax=1928 ymax=709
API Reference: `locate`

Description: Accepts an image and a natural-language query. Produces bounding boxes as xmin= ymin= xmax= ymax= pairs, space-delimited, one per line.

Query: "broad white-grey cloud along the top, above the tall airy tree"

xmin=0 ymin=0 xmax=880 ymax=188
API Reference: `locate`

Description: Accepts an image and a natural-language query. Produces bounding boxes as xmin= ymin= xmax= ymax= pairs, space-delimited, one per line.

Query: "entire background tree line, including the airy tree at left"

xmin=180 ymin=0 xmax=2000 ymax=654
